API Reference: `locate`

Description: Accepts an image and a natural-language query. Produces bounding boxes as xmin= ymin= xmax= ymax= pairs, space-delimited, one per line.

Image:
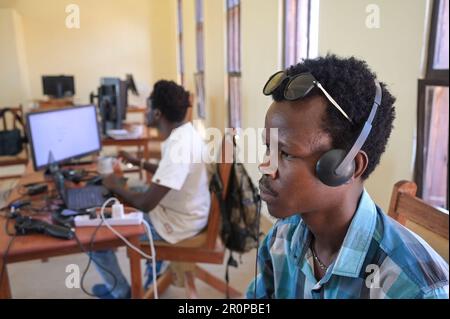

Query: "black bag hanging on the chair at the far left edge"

xmin=0 ymin=108 xmax=27 ymax=156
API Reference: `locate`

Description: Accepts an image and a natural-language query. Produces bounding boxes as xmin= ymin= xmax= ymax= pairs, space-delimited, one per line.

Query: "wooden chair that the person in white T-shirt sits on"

xmin=132 ymin=132 xmax=242 ymax=299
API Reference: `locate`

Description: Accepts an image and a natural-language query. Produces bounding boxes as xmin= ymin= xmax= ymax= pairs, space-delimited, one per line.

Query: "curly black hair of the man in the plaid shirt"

xmin=272 ymin=55 xmax=395 ymax=180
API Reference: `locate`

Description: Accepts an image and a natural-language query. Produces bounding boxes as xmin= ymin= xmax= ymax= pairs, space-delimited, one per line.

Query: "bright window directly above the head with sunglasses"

xmin=283 ymin=0 xmax=319 ymax=68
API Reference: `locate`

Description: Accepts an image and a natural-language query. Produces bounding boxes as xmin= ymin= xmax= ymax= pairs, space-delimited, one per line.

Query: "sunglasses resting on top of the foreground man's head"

xmin=263 ymin=71 xmax=353 ymax=123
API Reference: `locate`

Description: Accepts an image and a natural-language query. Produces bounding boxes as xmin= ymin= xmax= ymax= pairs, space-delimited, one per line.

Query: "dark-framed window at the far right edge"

xmin=415 ymin=0 xmax=449 ymax=208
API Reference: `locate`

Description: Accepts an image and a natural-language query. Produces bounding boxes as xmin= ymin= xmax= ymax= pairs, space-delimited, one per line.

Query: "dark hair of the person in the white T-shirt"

xmin=150 ymin=80 xmax=190 ymax=123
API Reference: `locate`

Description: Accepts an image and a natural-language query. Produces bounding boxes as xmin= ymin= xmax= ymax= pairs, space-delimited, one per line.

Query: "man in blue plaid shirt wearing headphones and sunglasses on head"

xmin=247 ymin=55 xmax=448 ymax=299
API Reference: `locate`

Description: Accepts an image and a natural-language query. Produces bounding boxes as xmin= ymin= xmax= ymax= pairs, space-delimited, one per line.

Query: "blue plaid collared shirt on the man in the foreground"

xmin=247 ymin=191 xmax=448 ymax=299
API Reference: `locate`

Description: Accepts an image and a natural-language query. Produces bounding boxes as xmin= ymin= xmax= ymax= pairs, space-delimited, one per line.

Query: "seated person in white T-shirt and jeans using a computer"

xmin=92 ymin=81 xmax=210 ymax=298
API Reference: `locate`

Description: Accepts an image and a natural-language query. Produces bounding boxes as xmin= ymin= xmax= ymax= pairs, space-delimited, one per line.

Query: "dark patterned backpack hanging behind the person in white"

xmin=210 ymin=162 xmax=261 ymax=298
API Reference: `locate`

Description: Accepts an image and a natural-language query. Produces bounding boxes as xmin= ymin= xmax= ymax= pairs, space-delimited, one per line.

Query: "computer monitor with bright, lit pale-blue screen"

xmin=26 ymin=105 xmax=102 ymax=170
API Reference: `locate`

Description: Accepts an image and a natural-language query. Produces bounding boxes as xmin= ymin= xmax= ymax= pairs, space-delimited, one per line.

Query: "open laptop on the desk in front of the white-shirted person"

xmin=52 ymin=170 xmax=110 ymax=210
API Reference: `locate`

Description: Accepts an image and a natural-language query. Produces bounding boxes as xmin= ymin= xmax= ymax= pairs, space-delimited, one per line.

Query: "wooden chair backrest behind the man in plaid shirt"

xmin=388 ymin=181 xmax=449 ymax=240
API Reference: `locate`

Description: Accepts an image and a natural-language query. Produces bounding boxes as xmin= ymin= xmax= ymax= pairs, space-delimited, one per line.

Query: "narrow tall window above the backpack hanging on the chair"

xmin=226 ymin=0 xmax=241 ymax=128
